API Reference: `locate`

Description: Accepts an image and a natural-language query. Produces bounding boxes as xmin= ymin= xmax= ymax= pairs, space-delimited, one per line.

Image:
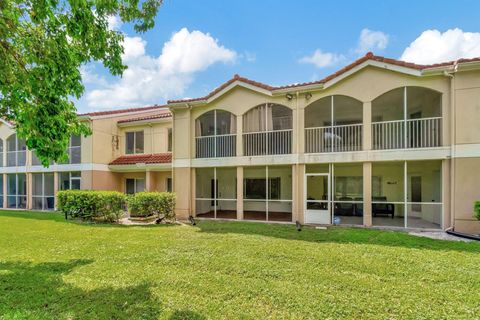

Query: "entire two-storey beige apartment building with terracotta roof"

xmin=0 ymin=53 xmax=480 ymax=233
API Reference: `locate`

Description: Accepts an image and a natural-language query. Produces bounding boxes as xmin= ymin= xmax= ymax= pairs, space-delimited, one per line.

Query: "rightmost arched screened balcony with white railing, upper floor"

xmin=372 ymin=87 xmax=442 ymax=150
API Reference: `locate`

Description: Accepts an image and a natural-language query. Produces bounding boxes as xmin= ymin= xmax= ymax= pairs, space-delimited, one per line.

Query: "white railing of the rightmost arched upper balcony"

xmin=372 ymin=117 xmax=442 ymax=150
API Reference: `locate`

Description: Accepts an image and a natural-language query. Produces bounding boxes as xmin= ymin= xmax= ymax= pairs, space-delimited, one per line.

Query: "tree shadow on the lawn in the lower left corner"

xmin=0 ymin=260 xmax=169 ymax=319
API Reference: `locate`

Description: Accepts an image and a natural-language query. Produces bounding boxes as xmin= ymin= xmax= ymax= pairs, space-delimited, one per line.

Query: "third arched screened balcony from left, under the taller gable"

xmin=305 ymin=96 xmax=363 ymax=153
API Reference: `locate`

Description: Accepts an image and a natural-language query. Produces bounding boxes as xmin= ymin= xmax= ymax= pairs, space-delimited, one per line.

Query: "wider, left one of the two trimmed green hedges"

xmin=57 ymin=190 xmax=126 ymax=222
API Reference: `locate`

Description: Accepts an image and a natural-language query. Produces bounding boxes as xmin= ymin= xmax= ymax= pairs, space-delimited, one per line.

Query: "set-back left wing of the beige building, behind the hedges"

xmin=0 ymin=106 xmax=172 ymax=210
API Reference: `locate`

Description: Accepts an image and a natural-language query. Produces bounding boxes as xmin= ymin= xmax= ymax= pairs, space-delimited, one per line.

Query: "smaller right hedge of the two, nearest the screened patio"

xmin=127 ymin=192 xmax=175 ymax=221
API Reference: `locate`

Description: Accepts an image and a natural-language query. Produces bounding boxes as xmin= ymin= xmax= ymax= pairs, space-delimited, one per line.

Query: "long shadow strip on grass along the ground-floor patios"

xmin=197 ymin=220 xmax=480 ymax=253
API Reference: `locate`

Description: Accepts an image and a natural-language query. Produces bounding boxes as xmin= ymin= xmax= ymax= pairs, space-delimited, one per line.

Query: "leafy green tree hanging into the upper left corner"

xmin=0 ymin=0 xmax=162 ymax=166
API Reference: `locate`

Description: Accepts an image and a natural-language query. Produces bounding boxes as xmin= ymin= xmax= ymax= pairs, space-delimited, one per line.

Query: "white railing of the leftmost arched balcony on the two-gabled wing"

xmin=195 ymin=134 xmax=237 ymax=158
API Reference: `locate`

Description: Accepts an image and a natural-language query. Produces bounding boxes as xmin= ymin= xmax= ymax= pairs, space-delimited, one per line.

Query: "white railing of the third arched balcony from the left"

xmin=305 ymin=124 xmax=363 ymax=153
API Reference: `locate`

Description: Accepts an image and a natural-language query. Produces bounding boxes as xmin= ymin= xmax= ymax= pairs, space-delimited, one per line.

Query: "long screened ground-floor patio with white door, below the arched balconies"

xmin=192 ymin=160 xmax=446 ymax=229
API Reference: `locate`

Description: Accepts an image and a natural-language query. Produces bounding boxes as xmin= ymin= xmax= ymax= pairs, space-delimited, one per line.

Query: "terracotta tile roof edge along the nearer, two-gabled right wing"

xmin=168 ymin=52 xmax=480 ymax=104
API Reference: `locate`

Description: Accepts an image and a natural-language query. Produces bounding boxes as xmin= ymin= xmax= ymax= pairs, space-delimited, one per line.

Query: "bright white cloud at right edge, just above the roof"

xmin=400 ymin=28 xmax=480 ymax=64
